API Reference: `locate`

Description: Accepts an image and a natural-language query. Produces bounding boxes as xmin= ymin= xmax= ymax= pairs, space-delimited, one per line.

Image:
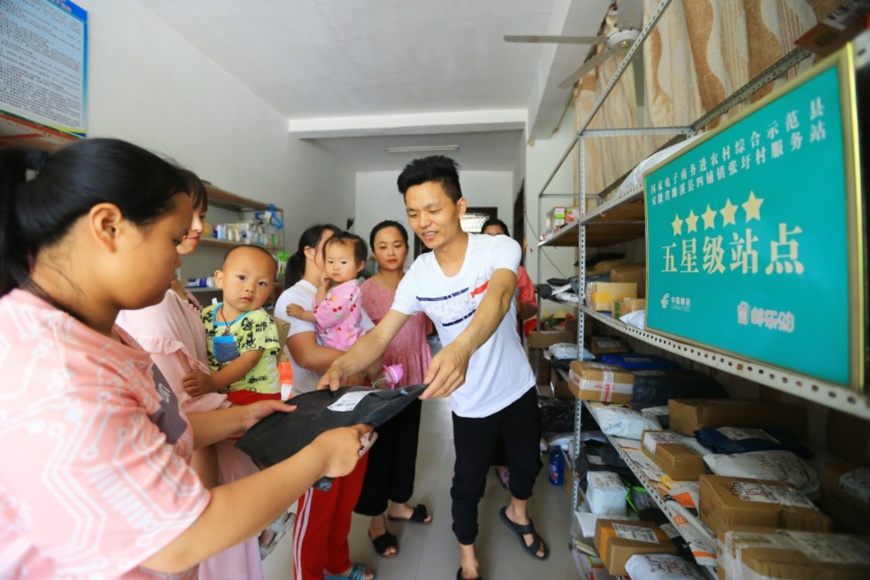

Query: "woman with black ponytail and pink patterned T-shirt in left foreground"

xmin=0 ymin=139 xmax=369 ymax=579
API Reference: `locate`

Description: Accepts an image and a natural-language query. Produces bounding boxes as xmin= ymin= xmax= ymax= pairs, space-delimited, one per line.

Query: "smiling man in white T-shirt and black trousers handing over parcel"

xmin=318 ymin=155 xmax=549 ymax=578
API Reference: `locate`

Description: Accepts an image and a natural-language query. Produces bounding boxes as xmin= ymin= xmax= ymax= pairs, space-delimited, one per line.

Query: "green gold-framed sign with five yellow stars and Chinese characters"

xmin=644 ymin=46 xmax=864 ymax=390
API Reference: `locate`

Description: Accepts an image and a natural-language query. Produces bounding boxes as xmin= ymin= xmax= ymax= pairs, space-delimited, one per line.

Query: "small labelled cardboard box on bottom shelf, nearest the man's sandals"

xmin=595 ymin=518 xmax=677 ymax=575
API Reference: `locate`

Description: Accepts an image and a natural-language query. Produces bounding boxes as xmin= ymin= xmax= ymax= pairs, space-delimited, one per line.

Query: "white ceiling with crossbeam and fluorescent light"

xmin=145 ymin=0 xmax=610 ymax=171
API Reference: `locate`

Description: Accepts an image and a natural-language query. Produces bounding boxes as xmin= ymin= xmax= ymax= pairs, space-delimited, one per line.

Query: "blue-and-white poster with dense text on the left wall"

xmin=0 ymin=0 xmax=88 ymax=145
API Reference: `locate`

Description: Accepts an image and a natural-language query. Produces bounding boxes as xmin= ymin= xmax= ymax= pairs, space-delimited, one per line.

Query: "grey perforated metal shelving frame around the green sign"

xmin=537 ymin=0 xmax=870 ymax=573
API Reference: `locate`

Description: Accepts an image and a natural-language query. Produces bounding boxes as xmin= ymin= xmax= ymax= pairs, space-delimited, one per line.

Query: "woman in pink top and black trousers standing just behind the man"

xmin=355 ymin=221 xmax=432 ymax=558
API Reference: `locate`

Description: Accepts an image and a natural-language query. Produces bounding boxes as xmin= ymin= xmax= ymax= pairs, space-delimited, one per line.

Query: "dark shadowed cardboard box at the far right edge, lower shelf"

xmin=819 ymin=462 xmax=870 ymax=534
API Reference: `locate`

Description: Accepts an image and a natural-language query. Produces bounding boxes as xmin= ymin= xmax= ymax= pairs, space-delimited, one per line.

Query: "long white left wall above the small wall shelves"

xmin=77 ymin=0 xmax=354 ymax=275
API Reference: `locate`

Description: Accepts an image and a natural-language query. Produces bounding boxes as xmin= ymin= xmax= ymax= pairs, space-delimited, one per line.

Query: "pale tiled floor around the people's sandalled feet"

xmin=263 ymin=399 xmax=578 ymax=580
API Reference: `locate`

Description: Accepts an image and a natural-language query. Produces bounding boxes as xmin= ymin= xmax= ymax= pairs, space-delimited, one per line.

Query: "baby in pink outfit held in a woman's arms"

xmin=287 ymin=232 xmax=368 ymax=350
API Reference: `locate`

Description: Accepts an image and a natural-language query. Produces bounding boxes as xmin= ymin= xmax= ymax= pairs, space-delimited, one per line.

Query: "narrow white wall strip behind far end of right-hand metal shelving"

xmin=525 ymin=109 xmax=577 ymax=315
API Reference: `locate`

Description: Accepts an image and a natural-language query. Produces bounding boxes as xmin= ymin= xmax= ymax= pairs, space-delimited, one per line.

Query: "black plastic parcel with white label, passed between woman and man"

xmin=236 ymin=385 xmax=426 ymax=489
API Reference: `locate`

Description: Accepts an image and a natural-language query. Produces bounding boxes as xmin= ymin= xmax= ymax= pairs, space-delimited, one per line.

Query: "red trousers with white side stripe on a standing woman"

xmin=293 ymin=454 xmax=369 ymax=580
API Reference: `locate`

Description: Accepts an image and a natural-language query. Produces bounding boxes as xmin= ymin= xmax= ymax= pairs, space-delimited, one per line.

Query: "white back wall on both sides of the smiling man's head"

xmin=353 ymin=170 xmax=516 ymax=256
